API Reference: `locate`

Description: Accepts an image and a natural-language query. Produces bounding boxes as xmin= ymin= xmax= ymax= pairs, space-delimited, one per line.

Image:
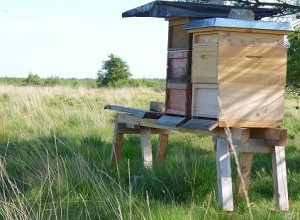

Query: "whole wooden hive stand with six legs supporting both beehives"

xmin=111 ymin=112 xmax=289 ymax=211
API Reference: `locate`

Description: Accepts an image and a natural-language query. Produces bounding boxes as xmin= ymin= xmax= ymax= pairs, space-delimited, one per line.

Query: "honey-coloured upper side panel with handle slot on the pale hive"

xmin=218 ymin=45 xmax=287 ymax=87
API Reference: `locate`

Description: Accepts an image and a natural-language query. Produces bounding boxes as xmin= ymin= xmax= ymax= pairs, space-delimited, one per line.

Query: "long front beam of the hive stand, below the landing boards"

xmin=117 ymin=114 xmax=250 ymax=140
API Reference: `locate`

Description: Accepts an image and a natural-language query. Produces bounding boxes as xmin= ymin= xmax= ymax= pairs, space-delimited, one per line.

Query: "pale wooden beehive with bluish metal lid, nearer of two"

xmin=186 ymin=18 xmax=292 ymax=128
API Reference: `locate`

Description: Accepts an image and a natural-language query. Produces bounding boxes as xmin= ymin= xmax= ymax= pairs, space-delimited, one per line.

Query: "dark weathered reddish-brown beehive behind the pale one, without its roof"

xmin=165 ymin=18 xmax=192 ymax=116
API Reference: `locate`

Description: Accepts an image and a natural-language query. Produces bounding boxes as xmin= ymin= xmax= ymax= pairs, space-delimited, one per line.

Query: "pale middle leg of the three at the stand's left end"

xmin=141 ymin=127 xmax=152 ymax=169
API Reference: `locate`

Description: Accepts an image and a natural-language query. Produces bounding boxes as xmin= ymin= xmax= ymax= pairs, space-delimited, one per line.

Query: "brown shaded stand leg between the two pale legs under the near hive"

xmin=236 ymin=153 xmax=253 ymax=198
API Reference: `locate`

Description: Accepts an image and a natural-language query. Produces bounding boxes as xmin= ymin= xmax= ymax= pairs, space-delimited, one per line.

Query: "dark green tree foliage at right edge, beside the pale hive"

xmin=287 ymin=28 xmax=300 ymax=87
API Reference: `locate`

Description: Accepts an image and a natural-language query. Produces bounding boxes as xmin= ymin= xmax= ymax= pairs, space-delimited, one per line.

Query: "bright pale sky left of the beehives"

xmin=0 ymin=0 xmax=168 ymax=78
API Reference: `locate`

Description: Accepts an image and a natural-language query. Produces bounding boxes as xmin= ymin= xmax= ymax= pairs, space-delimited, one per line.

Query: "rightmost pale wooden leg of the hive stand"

xmin=272 ymin=146 xmax=289 ymax=211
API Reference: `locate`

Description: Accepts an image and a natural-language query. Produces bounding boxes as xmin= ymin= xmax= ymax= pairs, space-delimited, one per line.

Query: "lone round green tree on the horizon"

xmin=97 ymin=54 xmax=131 ymax=87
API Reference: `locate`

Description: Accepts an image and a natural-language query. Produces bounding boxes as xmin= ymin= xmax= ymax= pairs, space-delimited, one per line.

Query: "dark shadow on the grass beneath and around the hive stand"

xmin=0 ymin=132 xmax=300 ymax=215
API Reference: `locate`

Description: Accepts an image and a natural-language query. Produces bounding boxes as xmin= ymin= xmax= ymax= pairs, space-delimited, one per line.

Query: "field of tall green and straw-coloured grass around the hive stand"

xmin=0 ymin=86 xmax=300 ymax=219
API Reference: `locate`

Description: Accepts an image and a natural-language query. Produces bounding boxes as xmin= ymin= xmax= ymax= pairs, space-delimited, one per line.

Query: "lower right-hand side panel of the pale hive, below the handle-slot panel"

xmin=219 ymin=83 xmax=284 ymax=128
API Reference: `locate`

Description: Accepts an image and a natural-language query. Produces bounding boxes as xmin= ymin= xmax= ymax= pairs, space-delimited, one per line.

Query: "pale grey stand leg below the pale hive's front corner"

xmin=216 ymin=138 xmax=233 ymax=211
